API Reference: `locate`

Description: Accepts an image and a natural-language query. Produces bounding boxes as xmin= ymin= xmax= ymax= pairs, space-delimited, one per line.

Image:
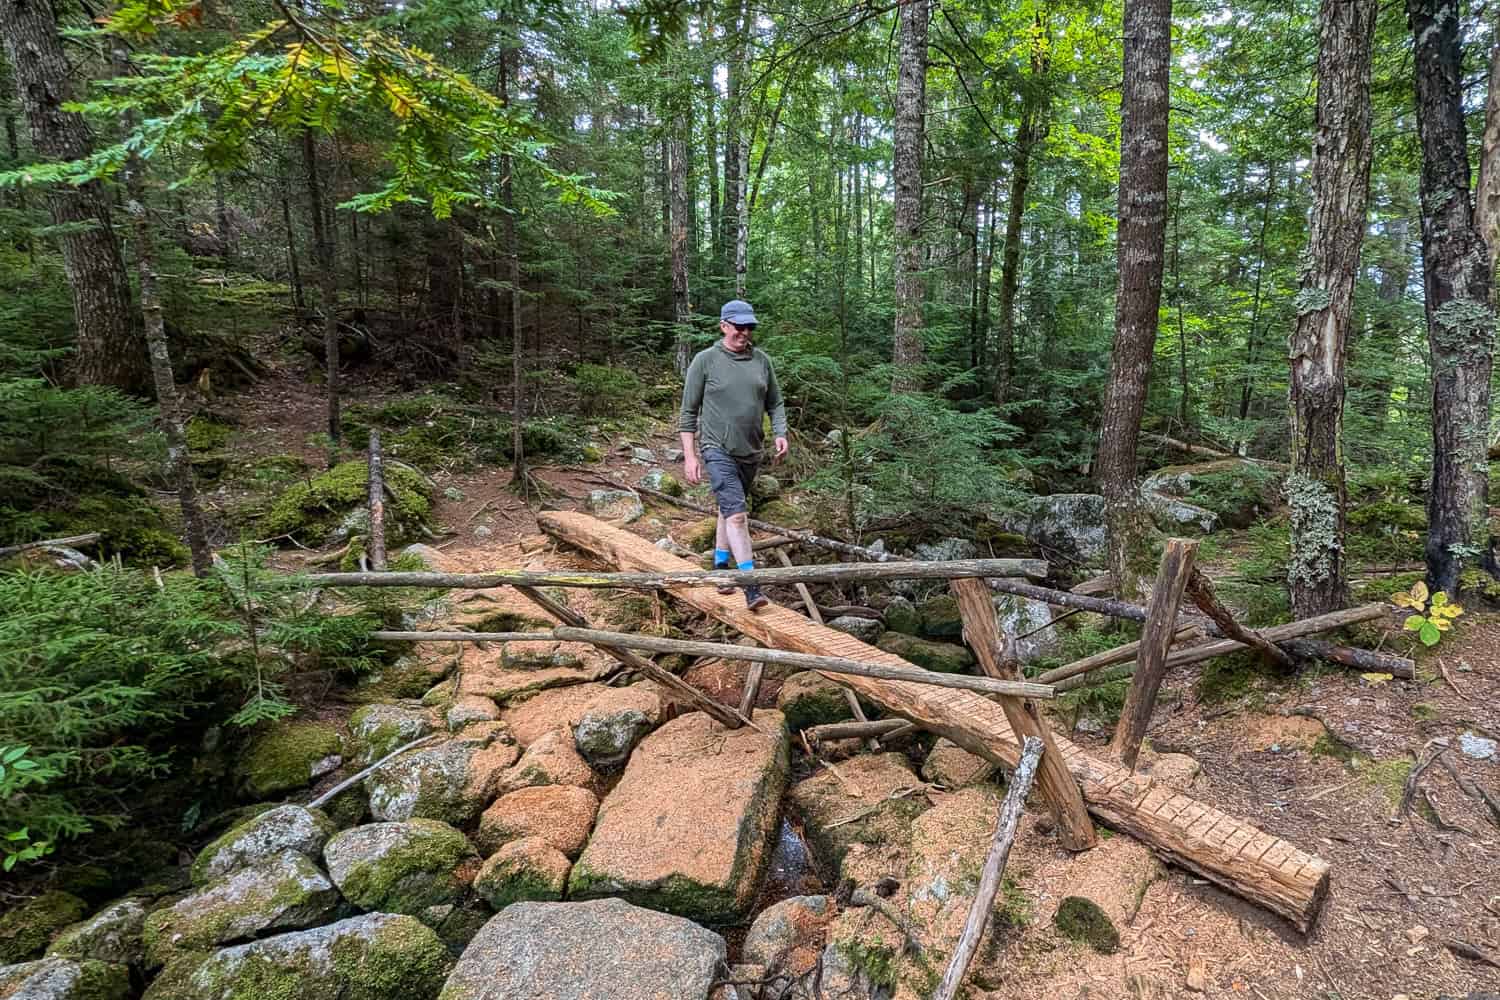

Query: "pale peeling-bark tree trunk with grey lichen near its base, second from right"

xmin=1287 ymin=0 xmax=1376 ymax=618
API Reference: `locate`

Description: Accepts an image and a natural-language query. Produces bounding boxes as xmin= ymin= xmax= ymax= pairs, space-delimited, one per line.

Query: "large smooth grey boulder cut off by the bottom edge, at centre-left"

xmin=441 ymin=900 xmax=728 ymax=1000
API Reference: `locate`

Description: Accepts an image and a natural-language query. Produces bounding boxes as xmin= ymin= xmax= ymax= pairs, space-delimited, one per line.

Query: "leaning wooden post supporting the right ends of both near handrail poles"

xmin=950 ymin=580 xmax=1098 ymax=850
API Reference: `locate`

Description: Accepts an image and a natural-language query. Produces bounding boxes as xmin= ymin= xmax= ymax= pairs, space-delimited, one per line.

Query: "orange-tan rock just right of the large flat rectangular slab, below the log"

xmin=788 ymin=753 xmax=927 ymax=885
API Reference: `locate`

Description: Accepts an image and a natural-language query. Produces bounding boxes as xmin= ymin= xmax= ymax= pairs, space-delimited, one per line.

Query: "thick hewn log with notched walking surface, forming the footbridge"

xmin=537 ymin=511 xmax=1329 ymax=933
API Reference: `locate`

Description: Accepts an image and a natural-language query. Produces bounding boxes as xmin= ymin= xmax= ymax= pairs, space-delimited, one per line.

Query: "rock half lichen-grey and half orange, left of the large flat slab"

xmin=365 ymin=739 xmax=521 ymax=826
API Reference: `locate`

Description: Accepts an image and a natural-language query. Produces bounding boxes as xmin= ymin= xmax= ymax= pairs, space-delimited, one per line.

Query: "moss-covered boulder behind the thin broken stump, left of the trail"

xmin=261 ymin=459 xmax=432 ymax=544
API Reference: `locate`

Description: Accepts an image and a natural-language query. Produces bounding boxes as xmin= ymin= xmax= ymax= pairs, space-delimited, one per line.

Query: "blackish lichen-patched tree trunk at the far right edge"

xmin=1407 ymin=0 xmax=1496 ymax=594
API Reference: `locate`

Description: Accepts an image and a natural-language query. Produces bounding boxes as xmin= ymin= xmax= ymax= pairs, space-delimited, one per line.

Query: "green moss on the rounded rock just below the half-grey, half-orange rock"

xmin=339 ymin=820 xmax=476 ymax=913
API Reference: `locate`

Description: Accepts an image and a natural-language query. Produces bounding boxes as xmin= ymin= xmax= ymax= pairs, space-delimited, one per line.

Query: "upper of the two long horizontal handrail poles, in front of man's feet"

xmin=301 ymin=559 xmax=1056 ymax=591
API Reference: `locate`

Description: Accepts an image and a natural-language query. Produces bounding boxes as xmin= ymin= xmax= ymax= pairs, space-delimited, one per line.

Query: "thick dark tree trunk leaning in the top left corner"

xmin=0 ymin=0 xmax=149 ymax=393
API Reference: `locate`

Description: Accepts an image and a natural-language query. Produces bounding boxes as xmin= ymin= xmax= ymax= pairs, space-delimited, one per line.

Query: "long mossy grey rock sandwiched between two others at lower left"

xmin=143 ymin=852 xmax=339 ymax=967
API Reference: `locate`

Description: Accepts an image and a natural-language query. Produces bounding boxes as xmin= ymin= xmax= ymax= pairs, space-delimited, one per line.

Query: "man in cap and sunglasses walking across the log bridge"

xmin=677 ymin=298 xmax=788 ymax=610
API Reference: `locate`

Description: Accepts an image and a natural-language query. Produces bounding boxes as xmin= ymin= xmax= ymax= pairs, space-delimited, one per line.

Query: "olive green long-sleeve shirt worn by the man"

xmin=677 ymin=340 xmax=786 ymax=459
